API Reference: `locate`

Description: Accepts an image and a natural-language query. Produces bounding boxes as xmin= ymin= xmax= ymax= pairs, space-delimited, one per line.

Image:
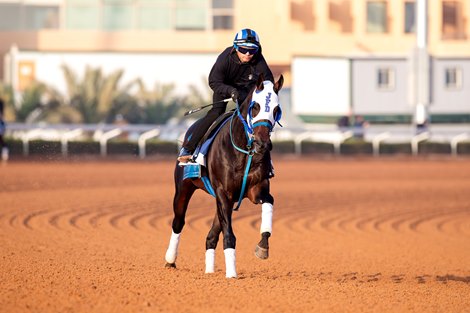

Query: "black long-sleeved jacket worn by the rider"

xmin=209 ymin=47 xmax=274 ymax=102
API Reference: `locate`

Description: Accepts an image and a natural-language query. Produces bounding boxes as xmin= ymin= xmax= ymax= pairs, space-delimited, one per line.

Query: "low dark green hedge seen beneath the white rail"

xmin=6 ymin=138 xmax=470 ymax=158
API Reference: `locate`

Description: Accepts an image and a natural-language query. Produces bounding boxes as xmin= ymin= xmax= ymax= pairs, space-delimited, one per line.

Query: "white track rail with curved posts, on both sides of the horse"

xmin=6 ymin=123 xmax=470 ymax=158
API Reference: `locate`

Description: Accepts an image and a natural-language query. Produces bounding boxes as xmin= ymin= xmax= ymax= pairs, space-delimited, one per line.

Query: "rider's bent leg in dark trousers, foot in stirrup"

xmin=178 ymin=102 xmax=227 ymax=163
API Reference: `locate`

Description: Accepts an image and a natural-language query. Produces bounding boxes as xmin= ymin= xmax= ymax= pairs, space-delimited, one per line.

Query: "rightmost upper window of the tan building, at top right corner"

xmin=442 ymin=1 xmax=466 ymax=39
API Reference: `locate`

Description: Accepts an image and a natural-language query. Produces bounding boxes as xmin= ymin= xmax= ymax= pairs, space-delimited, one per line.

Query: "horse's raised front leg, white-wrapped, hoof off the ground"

xmin=248 ymin=180 xmax=274 ymax=260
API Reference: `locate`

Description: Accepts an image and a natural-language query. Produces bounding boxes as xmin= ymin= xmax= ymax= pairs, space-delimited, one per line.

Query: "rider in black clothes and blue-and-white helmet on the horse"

xmin=178 ymin=28 xmax=274 ymax=163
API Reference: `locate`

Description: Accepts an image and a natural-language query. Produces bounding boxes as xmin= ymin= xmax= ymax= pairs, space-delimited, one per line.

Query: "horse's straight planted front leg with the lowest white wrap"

xmin=217 ymin=192 xmax=237 ymax=278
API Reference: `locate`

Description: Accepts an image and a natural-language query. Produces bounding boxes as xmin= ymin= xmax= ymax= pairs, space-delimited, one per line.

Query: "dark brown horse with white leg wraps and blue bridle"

xmin=165 ymin=75 xmax=284 ymax=278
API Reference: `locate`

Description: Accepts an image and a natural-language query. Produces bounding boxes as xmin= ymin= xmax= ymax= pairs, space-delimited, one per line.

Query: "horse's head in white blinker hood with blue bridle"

xmin=246 ymin=75 xmax=284 ymax=153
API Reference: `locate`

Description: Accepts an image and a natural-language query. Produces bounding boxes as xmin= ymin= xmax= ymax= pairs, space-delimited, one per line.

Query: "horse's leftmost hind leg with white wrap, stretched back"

xmin=165 ymin=182 xmax=196 ymax=267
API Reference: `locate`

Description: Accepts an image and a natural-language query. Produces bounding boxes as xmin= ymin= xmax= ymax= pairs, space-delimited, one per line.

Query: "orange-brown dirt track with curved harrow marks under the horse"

xmin=0 ymin=159 xmax=470 ymax=313
